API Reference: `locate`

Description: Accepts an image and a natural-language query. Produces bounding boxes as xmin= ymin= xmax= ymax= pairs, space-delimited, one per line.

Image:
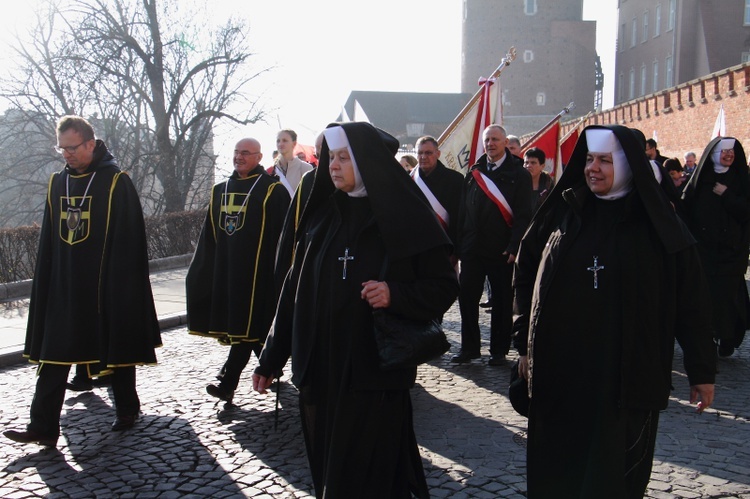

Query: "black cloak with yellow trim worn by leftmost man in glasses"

xmin=24 ymin=140 xmax=161 ymax=375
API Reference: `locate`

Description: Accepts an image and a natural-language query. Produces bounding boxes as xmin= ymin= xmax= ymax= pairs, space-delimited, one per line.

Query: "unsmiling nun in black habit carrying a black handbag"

xmin=253 ymin=123 xmax=458 ymax=498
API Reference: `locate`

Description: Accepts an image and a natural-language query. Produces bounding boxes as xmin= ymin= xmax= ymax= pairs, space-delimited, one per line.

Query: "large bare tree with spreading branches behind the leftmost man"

xmin=0 ymin=0 xmax=267 ymax=221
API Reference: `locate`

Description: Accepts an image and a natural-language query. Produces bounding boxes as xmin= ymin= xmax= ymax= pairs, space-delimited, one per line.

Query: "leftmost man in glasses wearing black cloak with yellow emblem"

xmin=5 ymin=116 xmax=161 ymax=446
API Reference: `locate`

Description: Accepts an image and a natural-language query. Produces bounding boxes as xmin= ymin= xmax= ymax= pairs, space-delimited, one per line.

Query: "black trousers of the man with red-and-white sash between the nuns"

xmin=458 ymin=255 xmax=513 ymax=355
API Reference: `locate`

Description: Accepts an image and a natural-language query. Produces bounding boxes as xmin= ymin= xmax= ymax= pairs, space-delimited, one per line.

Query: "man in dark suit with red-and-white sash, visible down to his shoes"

xmin=451 ymin=125 xmax=531 ymax=366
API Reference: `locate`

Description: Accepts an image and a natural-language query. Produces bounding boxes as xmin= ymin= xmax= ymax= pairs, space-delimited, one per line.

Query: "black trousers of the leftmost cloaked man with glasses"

xmin=28 ymin=362 xmax=141 ymax=437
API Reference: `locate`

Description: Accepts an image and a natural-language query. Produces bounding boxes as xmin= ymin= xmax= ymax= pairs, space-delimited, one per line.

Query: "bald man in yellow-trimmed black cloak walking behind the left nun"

xmin=186 ymin=138 xmax=289 ymax=403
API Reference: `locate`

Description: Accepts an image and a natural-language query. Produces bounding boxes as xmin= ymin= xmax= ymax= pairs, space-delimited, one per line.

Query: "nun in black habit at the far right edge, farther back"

xmin=682 ymin=137 xmax=750 ymax=357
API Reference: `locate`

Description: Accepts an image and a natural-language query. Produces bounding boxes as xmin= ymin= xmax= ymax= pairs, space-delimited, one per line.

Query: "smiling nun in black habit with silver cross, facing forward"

xmin=514 ymin=125 xmax=716 ymax=499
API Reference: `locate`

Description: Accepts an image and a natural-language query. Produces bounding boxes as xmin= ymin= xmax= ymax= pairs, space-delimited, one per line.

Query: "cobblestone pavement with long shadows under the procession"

xmin=0 ymin=305 xmax=750 ymax=499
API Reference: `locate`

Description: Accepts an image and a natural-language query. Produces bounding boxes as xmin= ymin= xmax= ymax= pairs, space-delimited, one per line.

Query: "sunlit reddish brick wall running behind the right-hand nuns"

xmin=564 ymin=63 xmax=750 ymax=161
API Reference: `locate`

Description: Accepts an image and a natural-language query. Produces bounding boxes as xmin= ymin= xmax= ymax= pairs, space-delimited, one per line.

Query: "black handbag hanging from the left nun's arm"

xmin=372 ymin=259 xmax=451 ymax=371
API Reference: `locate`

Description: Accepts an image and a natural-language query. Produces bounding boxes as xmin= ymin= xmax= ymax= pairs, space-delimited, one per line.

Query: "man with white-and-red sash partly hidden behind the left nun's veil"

xmin=410 ymin=135 xmax=464 ymax=265
